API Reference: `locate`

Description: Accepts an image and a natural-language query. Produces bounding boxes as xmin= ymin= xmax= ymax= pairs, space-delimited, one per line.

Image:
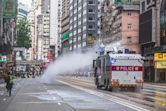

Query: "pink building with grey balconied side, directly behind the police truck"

xmin=101 ymin=0 xmax=140 ymax=53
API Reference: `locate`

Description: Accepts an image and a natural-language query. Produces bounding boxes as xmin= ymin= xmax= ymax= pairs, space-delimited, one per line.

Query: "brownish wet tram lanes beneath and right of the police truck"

xmin=60 ymin=77 xmax=166 ymax=111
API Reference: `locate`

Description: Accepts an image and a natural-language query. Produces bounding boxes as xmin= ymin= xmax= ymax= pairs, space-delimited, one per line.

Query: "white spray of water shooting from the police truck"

xmin=41 ymin=50 xmax=96 ymax=83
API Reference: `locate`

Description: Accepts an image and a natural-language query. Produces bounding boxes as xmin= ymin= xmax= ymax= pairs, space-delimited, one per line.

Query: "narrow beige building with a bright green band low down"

xmin=61 ymin=0 xmax=70 ymax=53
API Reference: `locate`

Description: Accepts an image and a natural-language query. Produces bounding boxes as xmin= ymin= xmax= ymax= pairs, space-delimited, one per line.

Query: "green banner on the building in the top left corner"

xmin=3 ymin=0 xmax=17 ymax=18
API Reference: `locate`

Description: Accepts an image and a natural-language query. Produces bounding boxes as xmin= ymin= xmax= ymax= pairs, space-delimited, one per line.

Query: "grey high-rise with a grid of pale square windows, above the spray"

xmin=69 ymin=0 xmax=98 ymax=51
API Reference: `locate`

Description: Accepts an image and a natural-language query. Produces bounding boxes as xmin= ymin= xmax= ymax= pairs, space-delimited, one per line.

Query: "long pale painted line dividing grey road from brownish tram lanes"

xmin=57 ymin=80 xmax=150 ymax=111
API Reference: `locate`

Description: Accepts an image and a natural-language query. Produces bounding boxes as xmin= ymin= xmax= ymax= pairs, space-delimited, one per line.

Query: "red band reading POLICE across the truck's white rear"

xmin=112 ymin=66 xmax=143 ymax=71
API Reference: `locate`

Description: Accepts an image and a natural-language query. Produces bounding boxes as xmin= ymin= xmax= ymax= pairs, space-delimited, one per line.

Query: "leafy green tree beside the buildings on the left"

xmin=17 ymin=18 xmax=31 ymax=49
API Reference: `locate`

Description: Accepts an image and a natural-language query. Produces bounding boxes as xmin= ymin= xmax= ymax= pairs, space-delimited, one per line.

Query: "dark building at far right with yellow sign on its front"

xmin=139 ymin=0 xmax=166 ymax=82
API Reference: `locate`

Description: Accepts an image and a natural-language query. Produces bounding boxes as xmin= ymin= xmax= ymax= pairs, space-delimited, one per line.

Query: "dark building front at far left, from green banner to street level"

xmin=0 ymin=0 xmax=17 ymax=76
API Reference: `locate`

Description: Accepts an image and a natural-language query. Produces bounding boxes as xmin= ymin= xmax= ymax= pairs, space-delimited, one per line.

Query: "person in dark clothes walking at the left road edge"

xmin=5 ymin=72 xmax=14 ymax=96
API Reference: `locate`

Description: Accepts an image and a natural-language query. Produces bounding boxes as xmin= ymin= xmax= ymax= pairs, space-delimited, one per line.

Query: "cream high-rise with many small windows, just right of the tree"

xmin=29 ymin=0 xmax=50 ymax=61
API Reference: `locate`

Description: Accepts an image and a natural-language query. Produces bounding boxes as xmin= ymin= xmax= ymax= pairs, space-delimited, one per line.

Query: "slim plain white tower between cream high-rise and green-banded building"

xmin=50 ymin=0 xmax=62 ymax=58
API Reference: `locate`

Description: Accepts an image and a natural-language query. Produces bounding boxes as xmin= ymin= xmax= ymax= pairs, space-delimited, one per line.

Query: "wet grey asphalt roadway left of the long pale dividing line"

xmin=0 ymin=78 xmax=145 ymax=111
